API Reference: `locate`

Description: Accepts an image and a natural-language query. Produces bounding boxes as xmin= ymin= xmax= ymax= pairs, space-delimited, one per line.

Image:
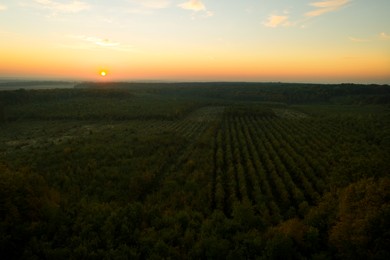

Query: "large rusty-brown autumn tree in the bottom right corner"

xmin=329 ymin=178 xmax=390 ymax=259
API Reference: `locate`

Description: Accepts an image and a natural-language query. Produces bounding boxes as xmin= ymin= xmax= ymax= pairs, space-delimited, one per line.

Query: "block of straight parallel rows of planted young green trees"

xmin=211 ymin=108 xmax=344 ymax=223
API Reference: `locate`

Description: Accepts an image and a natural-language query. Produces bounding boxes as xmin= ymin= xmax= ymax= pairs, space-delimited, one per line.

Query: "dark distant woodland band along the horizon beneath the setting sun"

xmin=75 ymin=82 xmax=390 ymax=104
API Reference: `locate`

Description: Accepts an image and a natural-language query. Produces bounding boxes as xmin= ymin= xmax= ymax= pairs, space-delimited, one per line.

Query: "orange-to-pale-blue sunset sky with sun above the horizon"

xmin=0 ymin=0 xmax=390 ymax=84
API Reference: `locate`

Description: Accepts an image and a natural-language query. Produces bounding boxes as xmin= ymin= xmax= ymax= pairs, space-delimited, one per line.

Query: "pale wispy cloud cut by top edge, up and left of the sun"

xmin=33 ymin=0 xmax=90 ymax=13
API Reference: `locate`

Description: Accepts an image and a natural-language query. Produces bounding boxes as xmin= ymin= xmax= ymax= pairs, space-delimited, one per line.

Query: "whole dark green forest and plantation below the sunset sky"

xmin=0 ymin=82 xmax=390 ymax=259
